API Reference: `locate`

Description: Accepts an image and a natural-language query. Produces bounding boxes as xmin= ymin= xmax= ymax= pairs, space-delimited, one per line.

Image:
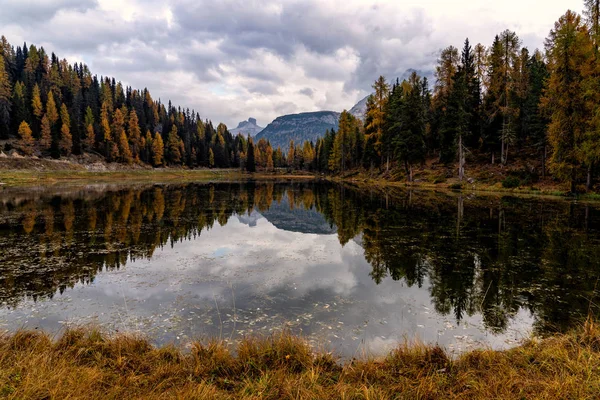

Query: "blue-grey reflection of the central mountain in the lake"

xmin=262 ymin=195 xmax=337 ymax=235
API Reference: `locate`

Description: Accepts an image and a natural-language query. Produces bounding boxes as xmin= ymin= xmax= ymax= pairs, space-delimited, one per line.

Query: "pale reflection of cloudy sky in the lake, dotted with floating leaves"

xmin=0 ymin=206 xmax=531 ymax=356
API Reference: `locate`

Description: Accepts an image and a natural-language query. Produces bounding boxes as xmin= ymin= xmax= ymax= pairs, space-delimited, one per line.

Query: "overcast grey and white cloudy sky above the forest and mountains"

xmin=0 ymin=0 xmax=583 ymax=127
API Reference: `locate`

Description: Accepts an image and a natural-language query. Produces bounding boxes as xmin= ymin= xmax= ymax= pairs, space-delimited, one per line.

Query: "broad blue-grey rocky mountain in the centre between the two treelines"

xmin=255 ymin=111 xmax=340 ymax=151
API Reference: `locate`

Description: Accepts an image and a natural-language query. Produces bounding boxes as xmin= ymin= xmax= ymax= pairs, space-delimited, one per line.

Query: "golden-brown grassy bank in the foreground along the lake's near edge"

xmin=0 ymin=323 xmax=600 ymax=399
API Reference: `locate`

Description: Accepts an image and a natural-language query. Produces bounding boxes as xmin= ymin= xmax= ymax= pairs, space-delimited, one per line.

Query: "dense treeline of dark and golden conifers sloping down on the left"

xmin=0 ymin=36 xmax=266 ymax=168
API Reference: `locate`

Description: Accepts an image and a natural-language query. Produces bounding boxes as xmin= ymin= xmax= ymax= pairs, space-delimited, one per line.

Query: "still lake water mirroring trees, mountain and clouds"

xmin=0 ymin=182 xmax=600 ymax=357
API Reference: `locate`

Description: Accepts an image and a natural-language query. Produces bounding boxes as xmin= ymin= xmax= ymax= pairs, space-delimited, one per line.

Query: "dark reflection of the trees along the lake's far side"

xmin=0 ymin=183 xmax=600 ymax=332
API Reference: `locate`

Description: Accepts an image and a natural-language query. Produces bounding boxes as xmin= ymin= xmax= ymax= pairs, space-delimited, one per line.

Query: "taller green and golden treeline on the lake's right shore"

xmin=289 ymin=0 xmax=600 ymax=191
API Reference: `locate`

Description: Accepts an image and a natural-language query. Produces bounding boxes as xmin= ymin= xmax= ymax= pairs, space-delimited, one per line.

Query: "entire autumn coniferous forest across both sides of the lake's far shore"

xmin=0 ymin=0 xmax=600 ymax=191
